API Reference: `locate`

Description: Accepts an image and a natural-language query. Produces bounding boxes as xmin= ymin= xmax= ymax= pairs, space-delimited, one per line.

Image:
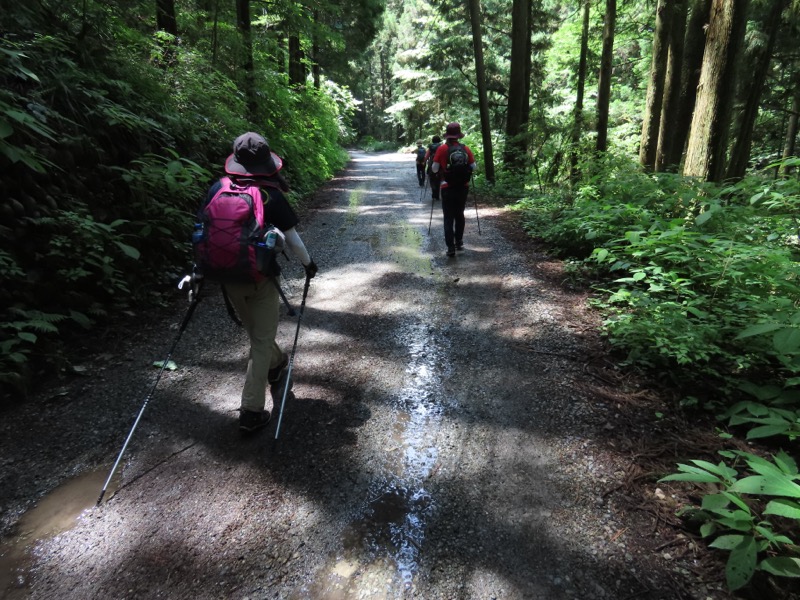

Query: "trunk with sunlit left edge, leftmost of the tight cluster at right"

xmin=639 ymin=0 xmax=673 ymax=170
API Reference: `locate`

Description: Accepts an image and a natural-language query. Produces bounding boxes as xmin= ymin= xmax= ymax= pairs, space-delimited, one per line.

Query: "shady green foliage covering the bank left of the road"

xmin=0 ymin=0 xmax=368 ymax=404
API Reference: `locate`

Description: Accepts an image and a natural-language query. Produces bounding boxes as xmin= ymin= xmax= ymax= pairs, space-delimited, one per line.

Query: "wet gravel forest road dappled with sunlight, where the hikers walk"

xmin=0 ymin=153 xmax=722 ymax=600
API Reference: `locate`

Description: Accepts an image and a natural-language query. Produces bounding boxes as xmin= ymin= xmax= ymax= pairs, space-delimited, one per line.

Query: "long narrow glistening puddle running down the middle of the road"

xmin=299 ymin=323 xmax=448 ymax=600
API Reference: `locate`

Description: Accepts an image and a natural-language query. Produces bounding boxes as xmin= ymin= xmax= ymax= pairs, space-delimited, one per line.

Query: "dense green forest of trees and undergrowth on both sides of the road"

xmin=0 ymin=0 xmax=800 ymax=590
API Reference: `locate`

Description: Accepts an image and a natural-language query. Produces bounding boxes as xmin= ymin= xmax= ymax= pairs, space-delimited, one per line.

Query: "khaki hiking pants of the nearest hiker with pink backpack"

xmin=225 ymin=279 xmax=283 ymax=411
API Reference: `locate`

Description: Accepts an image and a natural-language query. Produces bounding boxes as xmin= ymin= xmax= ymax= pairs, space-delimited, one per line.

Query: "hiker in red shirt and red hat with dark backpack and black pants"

xmin=431 ymin=123 xmax=476 ymax=256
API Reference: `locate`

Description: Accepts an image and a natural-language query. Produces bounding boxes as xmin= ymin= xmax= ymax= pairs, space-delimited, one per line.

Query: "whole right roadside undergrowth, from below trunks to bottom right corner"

xmin=494 ymin=165 xmax=800 ymax=598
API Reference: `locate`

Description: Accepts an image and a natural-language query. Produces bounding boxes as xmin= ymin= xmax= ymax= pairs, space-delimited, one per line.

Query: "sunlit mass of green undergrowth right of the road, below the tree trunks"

xmin=521 ymin=152 xmax=800 ymax=400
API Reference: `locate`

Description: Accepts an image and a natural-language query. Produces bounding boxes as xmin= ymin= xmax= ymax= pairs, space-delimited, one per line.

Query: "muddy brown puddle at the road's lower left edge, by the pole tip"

xmin=0 ymin=468 xmax=119 ymax=600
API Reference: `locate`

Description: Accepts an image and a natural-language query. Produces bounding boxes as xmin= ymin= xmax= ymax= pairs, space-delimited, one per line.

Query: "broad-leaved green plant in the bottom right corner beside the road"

xmin=660 ymin=451 xmax=800 ymax=591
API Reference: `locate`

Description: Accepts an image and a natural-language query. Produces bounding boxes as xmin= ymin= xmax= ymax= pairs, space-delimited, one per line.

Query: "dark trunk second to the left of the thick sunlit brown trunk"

xmin=655 ymin=0 xmax=686 ymax=171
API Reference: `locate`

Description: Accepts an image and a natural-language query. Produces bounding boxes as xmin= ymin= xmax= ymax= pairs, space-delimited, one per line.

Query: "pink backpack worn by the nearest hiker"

xmin=192 ymin=177 xmax=277 ymax=283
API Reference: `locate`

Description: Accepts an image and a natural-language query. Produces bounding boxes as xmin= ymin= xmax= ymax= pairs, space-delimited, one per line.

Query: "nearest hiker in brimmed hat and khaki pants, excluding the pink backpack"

xmin=206 ymin=132 xmax=317 ymax=432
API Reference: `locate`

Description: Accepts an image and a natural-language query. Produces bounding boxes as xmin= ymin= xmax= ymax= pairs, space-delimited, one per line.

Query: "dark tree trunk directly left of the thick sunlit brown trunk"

xmin=666 ymin=0 xmax=711 ymax=165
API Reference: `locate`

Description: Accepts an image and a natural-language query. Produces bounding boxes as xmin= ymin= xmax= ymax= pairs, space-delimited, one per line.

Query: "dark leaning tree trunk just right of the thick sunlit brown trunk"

xmin=726 ymin=0 xmax=786 ymax=179
